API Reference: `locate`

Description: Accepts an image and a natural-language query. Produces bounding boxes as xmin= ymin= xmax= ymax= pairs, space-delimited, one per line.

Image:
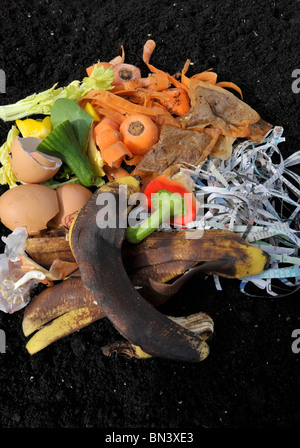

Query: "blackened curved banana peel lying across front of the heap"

xmin=69 ymin=176 xmax=209 ymax=362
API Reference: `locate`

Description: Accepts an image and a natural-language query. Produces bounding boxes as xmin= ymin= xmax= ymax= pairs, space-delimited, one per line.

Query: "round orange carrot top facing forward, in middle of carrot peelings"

xmin=120 ymin=114 xmax=159 ymax=154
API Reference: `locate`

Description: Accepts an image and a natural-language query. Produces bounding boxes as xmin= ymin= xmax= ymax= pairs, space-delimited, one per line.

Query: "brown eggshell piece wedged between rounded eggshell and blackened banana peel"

xmin=49 ymin=184 xmax=93 ymax=228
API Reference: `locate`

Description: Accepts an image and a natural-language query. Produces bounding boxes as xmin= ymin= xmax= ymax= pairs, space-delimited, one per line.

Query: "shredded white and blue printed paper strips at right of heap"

xmin=182 ymin=126 xmax=300 ymax=297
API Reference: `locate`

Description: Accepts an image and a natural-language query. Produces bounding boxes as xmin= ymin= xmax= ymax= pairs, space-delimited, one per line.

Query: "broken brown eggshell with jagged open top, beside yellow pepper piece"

xmin=10 ymin=136 xmax=62 ymax=184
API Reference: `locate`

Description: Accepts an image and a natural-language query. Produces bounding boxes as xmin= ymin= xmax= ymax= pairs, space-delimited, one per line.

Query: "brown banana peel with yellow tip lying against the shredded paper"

xmin=123 ymin=229 xmax=270 ymax=305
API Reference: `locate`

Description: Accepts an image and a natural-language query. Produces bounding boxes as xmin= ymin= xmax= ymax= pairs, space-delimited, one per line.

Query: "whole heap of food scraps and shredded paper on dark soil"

xmin=0 ymin=40 xmax=300 ymax=361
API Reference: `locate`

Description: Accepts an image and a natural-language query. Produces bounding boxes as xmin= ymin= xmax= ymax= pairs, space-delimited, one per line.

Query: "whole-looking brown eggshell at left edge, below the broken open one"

xmin=0 ymin=184 xmax=59 ymax=235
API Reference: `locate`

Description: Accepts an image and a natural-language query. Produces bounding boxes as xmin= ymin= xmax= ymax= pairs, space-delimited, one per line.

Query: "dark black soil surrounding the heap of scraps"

xmin=0 ymin=0 xmax=300 ymax=428
